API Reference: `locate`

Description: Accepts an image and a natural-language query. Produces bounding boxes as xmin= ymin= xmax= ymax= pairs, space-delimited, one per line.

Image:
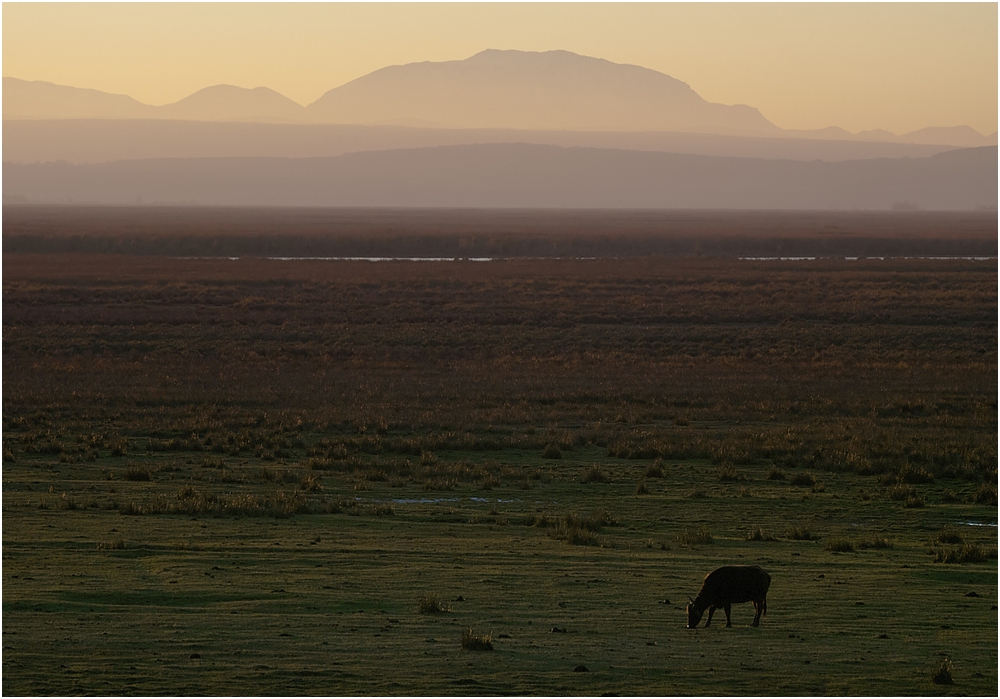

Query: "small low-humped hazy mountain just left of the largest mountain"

xmin=156 ymin=85 xmax=306 ymax=124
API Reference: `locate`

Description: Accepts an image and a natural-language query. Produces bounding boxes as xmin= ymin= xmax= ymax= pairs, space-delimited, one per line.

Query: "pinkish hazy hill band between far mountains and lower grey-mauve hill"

xmin=3 ymin=119 xmax=964 ymax=163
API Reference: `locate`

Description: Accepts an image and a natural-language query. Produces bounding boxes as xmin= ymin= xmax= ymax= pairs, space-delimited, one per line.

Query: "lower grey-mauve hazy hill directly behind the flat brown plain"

xmin=3 ymin=144 xmax=997 ymax=210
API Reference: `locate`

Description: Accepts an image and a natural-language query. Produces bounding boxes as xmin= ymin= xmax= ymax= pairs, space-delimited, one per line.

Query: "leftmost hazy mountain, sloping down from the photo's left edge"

xmin=3 ymin=78 xmax=155 ymax=120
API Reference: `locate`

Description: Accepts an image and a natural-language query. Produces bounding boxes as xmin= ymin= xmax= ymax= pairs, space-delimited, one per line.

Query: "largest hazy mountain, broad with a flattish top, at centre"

xmin=306 ymin=49 xmax=780 ymax=135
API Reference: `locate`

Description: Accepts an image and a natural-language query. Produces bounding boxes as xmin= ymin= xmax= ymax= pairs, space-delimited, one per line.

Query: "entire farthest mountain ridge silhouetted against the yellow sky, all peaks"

xmin=3 ymin=49 xmax=997 ymax=147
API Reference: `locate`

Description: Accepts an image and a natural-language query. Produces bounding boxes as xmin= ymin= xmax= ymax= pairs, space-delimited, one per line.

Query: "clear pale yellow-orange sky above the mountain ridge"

xmin=2 ymin=2 xmax=998 ymax=134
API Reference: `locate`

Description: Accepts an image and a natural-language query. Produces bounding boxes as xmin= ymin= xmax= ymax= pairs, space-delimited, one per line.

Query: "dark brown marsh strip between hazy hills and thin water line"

xmin=3 ymin=206 xmax=997 ymax=257
